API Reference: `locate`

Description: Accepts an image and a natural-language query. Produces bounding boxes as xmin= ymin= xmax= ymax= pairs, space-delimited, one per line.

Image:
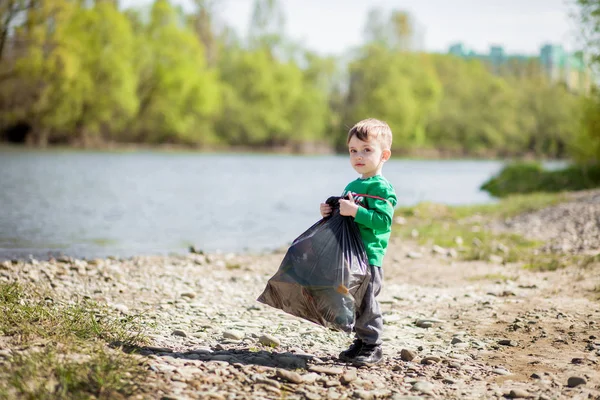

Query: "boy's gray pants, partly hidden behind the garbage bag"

xmin=354 ymin=265 xmax=383 ymax=345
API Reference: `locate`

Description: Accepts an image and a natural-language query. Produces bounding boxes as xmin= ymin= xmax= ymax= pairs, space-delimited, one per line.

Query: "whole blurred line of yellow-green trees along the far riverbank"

xmin=0 ymin=0 xmax=600 ymax=159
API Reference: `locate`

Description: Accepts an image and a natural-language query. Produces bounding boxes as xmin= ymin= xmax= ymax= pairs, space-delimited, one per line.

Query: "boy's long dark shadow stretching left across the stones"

xmin=118 ymin=345 xmax=323 ymax=370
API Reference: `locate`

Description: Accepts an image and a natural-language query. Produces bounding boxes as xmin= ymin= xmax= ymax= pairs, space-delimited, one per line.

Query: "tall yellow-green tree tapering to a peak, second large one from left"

xmin=129 ymin=0 xmax=221 ymax=144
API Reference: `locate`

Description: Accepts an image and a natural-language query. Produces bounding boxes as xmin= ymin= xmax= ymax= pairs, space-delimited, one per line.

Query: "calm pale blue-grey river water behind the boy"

xmin=0 ymin=151 xmax=552 ymax=259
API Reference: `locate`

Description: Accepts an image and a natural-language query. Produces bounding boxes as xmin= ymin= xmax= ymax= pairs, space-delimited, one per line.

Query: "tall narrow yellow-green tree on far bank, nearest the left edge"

xmin=66 ymin=1 xmax=139 ymax=146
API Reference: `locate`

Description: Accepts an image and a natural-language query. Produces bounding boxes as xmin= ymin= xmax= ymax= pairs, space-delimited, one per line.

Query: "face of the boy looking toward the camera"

xmin=348 ymin=136 xmax=391 ymax=178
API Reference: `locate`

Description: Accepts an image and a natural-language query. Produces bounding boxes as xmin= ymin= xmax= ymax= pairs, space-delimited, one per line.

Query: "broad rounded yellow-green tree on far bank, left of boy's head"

xmin=218 ymin=48 xmax=327 ymax=146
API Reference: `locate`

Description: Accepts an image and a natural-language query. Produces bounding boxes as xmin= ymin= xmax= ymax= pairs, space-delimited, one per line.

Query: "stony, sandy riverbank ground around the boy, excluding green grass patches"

xmin=0 ymin=192 xmax=600 ymax=399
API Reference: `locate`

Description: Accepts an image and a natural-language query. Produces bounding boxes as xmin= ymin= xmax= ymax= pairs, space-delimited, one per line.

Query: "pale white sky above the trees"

xmin=121 ymin=0 xmax=577 ymax=55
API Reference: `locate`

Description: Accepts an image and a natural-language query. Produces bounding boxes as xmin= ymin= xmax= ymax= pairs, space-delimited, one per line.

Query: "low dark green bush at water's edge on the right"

xmin=481 ymin=163 xmax=600 ymax=197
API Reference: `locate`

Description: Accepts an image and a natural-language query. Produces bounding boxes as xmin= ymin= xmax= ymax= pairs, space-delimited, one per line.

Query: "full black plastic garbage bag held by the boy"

xmin=257 ymin=197 xmax=371 ymax=332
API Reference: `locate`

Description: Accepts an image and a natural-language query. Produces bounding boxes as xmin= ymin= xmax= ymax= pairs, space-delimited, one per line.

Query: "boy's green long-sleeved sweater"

xmin=342 ymin=175 xmax=398 ymax=267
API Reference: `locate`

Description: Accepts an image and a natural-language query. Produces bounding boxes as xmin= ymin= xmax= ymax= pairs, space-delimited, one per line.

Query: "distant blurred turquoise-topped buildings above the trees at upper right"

xmin=448 ymin=43 xmax=592 ymax=93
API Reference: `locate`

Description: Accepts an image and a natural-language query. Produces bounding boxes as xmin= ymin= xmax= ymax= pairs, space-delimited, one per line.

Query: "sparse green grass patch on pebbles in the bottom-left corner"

xmin=0 ymin=283 xmax=147 ymax=399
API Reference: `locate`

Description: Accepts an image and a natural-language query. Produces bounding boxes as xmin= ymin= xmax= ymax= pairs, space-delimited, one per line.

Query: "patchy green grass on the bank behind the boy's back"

xmin=394 ymin=193 xmax=574 ymax=270
